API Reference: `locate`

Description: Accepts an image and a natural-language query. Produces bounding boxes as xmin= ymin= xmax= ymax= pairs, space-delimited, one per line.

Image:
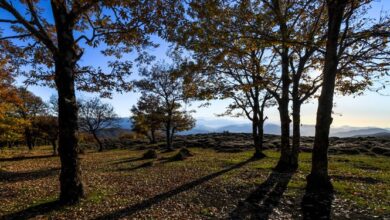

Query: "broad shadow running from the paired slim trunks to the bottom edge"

xmin=230 ymin=171 xmax=293 ymax=219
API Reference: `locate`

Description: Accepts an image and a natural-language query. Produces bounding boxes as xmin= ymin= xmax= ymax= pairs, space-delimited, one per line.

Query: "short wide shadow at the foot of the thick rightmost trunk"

xmin=301 ymin=186 xmax=334 ymax=220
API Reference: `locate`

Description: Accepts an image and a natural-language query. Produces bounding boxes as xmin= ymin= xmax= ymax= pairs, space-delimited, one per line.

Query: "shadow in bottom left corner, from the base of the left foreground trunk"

xmin=0 ymin=200 xmax=63 ymax=220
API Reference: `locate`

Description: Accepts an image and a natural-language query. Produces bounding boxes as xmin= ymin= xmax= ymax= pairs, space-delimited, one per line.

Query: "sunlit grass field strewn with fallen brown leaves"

xmin=0 ymin=147 xmax=390 ymax=219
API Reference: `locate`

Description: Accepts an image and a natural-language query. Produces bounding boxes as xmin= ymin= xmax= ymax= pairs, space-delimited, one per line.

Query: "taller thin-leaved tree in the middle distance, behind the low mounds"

xmin=135 ymin=64 xmax=195 ymax=150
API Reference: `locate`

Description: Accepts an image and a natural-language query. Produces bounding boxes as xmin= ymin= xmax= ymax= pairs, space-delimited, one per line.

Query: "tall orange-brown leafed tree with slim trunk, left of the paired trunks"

xmin=170 ymin=0 xmax=279 ymax=158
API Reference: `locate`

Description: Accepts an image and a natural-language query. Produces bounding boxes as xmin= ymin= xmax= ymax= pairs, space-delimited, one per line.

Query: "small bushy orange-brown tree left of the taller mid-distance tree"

xmin=130 ymin=95 xmax=163 ymax=144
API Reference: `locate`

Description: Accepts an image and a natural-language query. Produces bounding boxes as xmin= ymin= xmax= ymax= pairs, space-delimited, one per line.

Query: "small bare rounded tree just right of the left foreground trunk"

xmin=79 ymin=98 xmax=117 ymax=152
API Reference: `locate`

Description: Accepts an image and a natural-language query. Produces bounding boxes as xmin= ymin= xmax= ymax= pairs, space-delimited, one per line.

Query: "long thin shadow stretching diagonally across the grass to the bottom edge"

xmin=95 ymin=159 xmax=252 ymax=220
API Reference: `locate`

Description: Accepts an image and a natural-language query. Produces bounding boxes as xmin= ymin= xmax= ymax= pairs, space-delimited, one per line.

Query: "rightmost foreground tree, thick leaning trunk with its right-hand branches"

xmin=307 ymin=0 xmax=390 ymax=190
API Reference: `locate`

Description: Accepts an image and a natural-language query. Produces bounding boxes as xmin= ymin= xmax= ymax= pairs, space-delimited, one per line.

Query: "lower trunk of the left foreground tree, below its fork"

xmin=56 ymin=60 xmax=84 ymax=203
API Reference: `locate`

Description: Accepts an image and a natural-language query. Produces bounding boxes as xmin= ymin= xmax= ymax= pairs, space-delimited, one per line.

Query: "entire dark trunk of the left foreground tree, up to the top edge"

xmin=51 ymin=0 xmax=84 ymax=204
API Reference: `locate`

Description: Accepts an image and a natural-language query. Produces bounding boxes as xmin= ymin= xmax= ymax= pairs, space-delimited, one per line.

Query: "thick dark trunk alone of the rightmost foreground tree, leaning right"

xmin=307 ymin=0 xmax=347 ymax=189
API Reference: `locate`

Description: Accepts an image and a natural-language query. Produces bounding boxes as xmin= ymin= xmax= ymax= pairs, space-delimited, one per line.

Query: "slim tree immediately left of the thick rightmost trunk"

xmin=289 ymin=1 xmax=326 ymax=169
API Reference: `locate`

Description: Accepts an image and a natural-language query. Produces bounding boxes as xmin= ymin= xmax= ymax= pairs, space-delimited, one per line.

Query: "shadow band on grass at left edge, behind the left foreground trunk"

xmin=0 ymin=168 xmax=60 ymax=183
